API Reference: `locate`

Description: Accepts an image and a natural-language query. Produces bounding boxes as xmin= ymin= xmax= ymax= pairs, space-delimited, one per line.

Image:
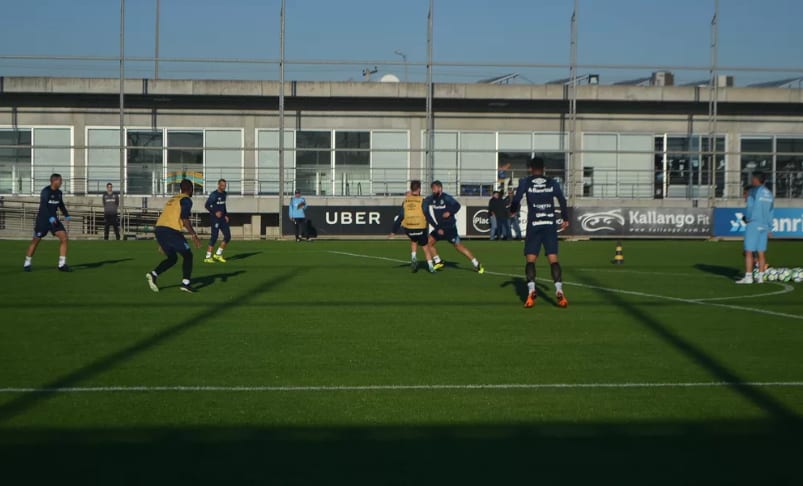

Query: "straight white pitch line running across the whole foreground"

xmin=0 ymin=381 xmax=803 ymax=394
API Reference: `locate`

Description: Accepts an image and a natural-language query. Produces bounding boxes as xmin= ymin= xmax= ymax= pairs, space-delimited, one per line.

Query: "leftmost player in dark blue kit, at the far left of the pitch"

xmin=22 ymin=174 xmax=71 ymax=272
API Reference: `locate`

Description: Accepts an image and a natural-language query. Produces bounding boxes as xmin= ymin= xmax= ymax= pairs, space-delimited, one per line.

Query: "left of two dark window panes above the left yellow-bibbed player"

xmin=126 ymin=130 xmax=166 ymax=194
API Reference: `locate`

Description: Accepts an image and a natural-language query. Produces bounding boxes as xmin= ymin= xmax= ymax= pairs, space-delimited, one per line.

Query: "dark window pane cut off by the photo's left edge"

xmin=0 ymin=128 xmax=32 ymax=194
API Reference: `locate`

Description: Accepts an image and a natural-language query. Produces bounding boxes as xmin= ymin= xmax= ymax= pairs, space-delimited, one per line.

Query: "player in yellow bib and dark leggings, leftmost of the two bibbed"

xmin=145 ymin=179 xmax=201 ymax=293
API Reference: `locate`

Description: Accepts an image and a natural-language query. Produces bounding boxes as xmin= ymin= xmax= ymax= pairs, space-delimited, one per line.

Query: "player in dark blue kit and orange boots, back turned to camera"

xmin=511 ymin=157 xmax=569 ymax=308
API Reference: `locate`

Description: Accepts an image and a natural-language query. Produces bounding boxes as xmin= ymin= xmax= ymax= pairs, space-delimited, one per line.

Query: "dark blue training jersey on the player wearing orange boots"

xmin=511 ymin=176 xmax=568 ymax=229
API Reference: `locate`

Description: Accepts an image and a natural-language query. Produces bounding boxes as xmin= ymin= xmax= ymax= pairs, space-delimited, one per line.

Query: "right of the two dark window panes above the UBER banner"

xmin=334 ymin=131 xmax=371 ymax=196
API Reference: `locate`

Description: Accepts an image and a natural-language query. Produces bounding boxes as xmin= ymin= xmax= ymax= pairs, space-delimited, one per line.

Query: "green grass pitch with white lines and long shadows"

xmin=0 ymin=239 xmax=803 ymax=484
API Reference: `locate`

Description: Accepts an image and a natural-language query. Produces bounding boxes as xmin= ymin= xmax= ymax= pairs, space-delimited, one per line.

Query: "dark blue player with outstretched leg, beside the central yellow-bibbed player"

xmin=424 ymin=181 xmax=485 ymax=274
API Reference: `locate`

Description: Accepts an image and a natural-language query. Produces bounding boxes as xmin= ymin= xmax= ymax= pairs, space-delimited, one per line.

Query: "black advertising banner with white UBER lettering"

xmin=282 ymin=206 xmax=399 ymax=236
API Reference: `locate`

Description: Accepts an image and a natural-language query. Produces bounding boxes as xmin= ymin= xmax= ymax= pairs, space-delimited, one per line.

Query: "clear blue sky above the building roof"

xmin=0 ymin=0 xmax=803 ymax=83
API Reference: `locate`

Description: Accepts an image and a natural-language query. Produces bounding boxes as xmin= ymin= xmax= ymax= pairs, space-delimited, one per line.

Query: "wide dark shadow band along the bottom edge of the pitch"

xmin=0 ymin=420 xmax=801 ymax=486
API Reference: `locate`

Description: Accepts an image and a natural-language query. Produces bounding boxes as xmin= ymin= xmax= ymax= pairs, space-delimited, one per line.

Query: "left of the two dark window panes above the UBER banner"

xmin=296 ymin=131 xmax=333 ymax=196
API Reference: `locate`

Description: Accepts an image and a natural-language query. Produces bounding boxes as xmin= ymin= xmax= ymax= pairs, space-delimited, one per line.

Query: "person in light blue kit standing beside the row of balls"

xmin=736 ymin=172 xmax=775 ymax=284
